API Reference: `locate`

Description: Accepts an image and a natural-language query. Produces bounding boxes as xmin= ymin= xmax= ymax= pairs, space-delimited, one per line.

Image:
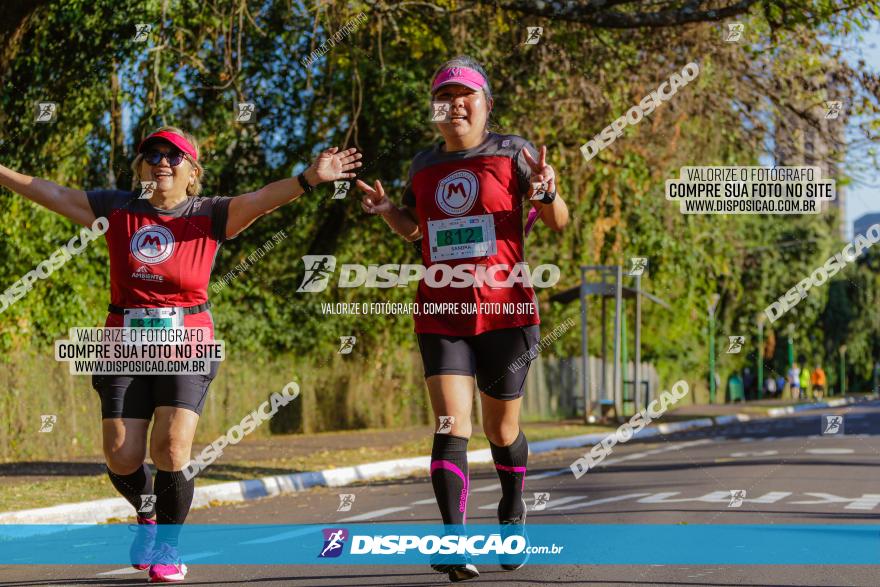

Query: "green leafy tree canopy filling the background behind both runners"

xmin=0 ymin=0 xmax=880 ymax=396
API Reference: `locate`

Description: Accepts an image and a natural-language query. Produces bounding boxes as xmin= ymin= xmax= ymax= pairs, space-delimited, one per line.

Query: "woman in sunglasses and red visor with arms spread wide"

xmin=0 ymin=127 xmax=361 ymax=582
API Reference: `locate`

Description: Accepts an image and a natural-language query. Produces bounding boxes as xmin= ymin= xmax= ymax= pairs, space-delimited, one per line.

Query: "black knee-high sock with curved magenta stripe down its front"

xmin=431 ymin=434 xmax=469 ymax=526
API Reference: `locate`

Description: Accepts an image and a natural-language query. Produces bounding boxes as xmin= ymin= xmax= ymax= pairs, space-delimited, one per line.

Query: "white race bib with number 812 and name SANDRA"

xmin=428 ymin=214 xmax=498 ymax=262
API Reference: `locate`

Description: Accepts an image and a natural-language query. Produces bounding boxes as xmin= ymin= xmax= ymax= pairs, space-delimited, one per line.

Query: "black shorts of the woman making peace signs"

xmin=417 ymin=324 xmax=541 ymax=400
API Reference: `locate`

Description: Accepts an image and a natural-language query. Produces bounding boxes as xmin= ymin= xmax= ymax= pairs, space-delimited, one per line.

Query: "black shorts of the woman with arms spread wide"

xmin=92 ymin=361 xmax=220 ymax=420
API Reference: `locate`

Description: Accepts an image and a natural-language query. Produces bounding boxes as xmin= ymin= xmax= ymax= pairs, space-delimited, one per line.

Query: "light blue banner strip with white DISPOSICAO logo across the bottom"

xmin=0 ymin=524 xmax=880 ymax=565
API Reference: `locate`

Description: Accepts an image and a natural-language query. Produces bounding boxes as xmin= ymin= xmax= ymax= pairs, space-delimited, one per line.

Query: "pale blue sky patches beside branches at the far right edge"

xmin=839 ymin=21 xmax=880 ymax=236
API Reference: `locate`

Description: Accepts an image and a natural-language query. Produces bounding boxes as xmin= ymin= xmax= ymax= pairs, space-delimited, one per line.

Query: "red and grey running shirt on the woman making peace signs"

xmin=403 ymin=133 xmax=541 ymax=336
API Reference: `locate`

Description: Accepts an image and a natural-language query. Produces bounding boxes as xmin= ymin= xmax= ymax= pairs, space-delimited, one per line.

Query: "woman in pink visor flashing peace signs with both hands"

xmin=358 ymin=56 xmax=568 ymax=582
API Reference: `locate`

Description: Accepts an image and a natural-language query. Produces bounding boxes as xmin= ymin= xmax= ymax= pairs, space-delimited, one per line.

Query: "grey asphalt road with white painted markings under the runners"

xmin=0 ymin=401 xmax=880 ymax=587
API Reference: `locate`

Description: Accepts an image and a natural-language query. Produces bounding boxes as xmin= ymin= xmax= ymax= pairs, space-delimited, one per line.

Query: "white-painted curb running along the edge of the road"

xmin=0 ymin=397 xmax=865 ymax=525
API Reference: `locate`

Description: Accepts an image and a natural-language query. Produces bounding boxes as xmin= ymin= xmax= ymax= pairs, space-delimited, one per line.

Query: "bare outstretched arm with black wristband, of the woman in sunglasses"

xmin=226 ymin=147 xmax=361 ymax=238
